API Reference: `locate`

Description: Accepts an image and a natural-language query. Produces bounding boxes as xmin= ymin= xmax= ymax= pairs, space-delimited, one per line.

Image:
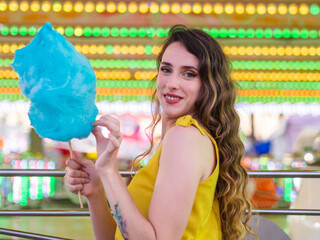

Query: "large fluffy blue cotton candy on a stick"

xmin=12 ymin=23 xmax=98 ymax=141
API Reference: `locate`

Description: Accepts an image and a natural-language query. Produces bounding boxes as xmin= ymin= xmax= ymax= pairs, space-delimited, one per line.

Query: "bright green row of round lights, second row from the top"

xmin=0 ymin=25 xmax=320 ymax=39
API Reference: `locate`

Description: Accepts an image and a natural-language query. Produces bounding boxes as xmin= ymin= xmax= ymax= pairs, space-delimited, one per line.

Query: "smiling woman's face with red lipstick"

xmin=157 ymin=42 xmax=201 ymax=119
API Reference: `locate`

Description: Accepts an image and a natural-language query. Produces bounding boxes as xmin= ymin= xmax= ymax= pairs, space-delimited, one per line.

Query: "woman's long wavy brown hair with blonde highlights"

xmin=134 ymin=25 xmax=257 ymax=240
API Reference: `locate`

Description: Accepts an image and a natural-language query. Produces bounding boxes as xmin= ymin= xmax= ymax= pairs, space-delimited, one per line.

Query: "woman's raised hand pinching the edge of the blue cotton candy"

xmin=92 ymin=115 xmax=122 ymax=171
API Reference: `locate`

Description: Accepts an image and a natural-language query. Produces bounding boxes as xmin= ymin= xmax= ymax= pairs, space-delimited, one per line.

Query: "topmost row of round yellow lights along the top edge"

xmin=0 ymin=0 xmax=320 ymax=15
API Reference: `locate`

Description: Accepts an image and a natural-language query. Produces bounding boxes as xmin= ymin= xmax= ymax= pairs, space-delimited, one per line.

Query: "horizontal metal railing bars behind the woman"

xmin=0 ymin=169 xmax=320 ymax=240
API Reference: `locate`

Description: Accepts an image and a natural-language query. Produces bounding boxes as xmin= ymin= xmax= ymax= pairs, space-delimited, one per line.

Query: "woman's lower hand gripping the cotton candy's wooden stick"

xmin=64 ymin=154 xmax=104 ymax=198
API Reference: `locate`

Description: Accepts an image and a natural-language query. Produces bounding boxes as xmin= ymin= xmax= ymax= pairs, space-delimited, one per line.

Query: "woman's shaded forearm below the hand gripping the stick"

xmin=87 ymin=188 xmax=116 ymax=240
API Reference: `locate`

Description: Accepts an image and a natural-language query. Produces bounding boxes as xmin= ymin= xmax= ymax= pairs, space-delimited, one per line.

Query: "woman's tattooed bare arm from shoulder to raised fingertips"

xmin=94 ymin=115 xmax=213 ymax=240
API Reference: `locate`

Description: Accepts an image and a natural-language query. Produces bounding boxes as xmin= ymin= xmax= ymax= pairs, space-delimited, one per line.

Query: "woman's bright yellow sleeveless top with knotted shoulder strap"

xmin=115 ymin=115 xmax=222 ymax=240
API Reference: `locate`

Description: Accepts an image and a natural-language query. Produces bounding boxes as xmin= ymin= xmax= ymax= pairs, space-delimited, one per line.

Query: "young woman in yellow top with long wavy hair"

xmin=65 ymin=25 xmax=251 ymax=240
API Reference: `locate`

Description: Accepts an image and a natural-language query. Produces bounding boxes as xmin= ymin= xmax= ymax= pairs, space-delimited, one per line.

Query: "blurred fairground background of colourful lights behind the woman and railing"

xmin=0 ymin=0 xmax=320 ymax=240
